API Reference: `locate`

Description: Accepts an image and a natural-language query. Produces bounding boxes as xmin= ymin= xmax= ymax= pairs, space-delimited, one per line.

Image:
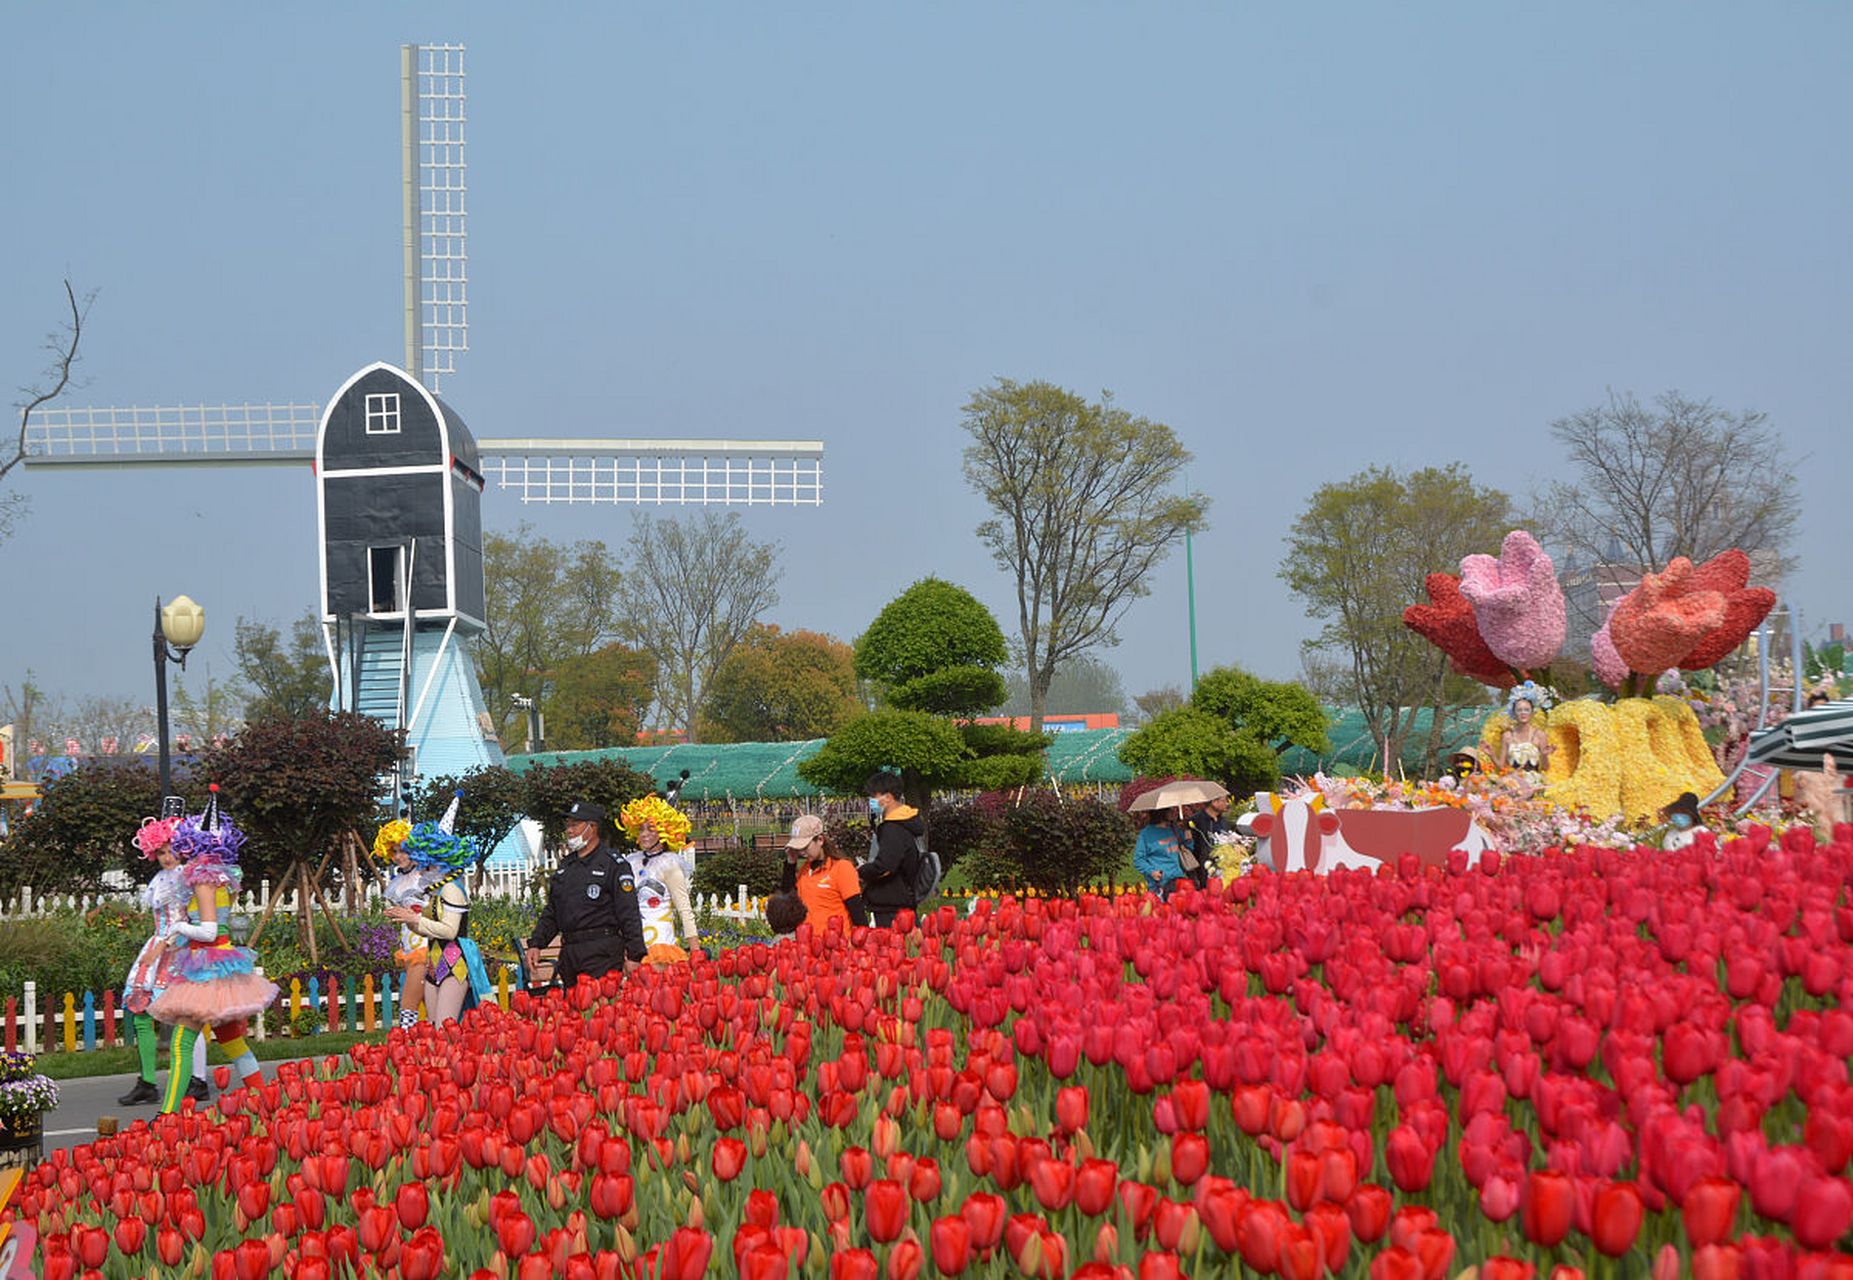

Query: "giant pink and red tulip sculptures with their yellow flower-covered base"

xmin=1403 ymin=530 xmax=1775 ymax=822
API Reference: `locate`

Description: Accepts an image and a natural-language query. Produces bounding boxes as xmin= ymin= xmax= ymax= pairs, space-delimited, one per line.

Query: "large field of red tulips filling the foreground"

xmin=7 ymin=826 xmax=1853 ymax=1280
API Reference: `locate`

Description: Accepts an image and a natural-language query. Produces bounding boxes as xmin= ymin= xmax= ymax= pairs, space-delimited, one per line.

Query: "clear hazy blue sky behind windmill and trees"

xmin=0 ymin=4 xmax=1853 ymax=711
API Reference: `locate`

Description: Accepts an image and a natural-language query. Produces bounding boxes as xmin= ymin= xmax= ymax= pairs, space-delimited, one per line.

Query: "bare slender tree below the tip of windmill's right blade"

xmin=617 ymin=511 xmax=780 ymax=743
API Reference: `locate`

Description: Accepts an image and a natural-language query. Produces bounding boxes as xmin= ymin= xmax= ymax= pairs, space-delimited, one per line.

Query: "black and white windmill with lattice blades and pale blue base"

xmin=26 ymin=44 xmax=823 ymax=859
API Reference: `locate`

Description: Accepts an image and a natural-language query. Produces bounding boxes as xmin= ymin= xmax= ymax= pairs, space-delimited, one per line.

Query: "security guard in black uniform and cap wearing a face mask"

xmin=528 ymin=800 xmax=649 ymax=989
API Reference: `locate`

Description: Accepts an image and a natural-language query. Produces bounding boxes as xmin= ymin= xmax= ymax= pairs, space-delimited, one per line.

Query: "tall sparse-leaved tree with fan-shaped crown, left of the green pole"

xmin=964 ymin=378 xmax=1208 ymax=730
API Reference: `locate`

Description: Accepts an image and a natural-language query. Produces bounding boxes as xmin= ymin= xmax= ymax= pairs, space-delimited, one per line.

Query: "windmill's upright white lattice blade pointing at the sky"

xmin=400 ymin=44 xmax=469 ymax=391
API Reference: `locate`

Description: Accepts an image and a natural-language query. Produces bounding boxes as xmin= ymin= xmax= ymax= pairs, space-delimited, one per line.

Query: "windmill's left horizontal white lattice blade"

xmin=26 ymin=402 xmax=322 ymax=469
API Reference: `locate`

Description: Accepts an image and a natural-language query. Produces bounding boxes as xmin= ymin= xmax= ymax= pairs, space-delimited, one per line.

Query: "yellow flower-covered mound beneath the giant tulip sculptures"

xmin=1481 ymin=696 xmax=1725 ymax=822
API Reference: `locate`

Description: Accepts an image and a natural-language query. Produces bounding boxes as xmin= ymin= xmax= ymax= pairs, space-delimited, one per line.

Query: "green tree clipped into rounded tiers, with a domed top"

xmin=799 ymin=578 xmax=1047 ymax=813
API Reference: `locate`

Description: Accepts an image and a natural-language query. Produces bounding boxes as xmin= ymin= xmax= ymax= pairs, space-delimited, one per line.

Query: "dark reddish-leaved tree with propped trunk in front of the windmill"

xmin=195 ymin=708 xmax=400 ymax=960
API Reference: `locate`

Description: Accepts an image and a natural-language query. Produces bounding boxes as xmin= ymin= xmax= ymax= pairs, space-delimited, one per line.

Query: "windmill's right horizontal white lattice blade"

xmin=476 ymin=439 xmax=823 ymax=506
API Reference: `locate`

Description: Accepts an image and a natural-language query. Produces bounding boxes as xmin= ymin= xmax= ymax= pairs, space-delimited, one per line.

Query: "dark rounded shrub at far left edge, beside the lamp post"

xmin=0 ymin=759 xmax=161 ymax=895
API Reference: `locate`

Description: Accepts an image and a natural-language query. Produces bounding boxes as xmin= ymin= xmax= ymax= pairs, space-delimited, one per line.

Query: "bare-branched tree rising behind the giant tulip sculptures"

xmin=1532 ymin=391 xmax=1801 ymax=621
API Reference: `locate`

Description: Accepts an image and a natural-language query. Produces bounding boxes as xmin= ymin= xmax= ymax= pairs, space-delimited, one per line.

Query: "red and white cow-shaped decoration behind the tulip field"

xmin=1236 ymin=791 xmax=1494 ymax=874
